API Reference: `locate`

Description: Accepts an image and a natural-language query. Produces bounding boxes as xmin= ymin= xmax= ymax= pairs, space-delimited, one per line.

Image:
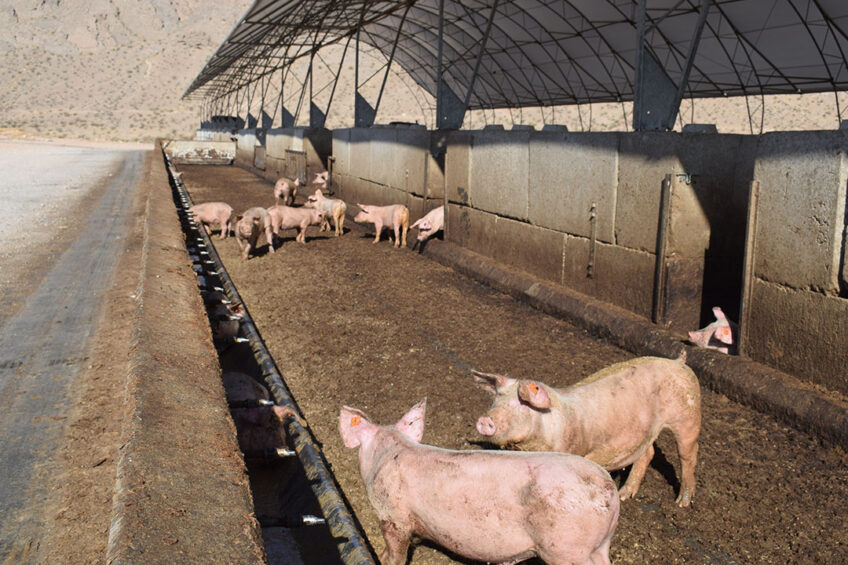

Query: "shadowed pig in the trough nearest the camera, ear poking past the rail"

xmin=221 ymin=371 xmax=300 ymax=452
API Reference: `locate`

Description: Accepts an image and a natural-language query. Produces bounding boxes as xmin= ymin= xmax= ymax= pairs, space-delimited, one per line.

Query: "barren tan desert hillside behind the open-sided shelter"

xmin=0 ymin=0 xmax=848 ymax=141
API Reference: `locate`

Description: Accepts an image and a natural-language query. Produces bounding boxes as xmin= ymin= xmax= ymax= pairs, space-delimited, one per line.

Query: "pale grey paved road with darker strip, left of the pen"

xmin=0 ymin=143 xmax=144 ymax=563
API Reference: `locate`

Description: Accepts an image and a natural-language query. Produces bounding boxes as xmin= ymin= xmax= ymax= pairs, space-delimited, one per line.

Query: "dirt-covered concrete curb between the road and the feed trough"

xmin=106 ymin=150 xmax=265 ymax=564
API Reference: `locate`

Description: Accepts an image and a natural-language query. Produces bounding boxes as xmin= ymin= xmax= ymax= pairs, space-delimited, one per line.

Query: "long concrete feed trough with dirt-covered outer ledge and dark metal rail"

xmin=106 ymin=143 xmax=374 ymax=564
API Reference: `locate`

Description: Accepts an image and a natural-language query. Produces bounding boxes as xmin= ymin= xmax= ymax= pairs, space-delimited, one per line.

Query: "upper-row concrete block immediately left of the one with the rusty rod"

xmin=469 ymin=131 xmax=530 ymax=220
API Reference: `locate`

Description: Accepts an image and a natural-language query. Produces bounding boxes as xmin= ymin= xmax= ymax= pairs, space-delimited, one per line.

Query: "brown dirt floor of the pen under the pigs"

xmin=181 ymin=166 xmax=848 ymax=565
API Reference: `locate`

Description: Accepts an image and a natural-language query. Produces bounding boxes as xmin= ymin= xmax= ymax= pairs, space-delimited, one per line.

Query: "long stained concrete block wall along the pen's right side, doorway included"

xmin=332 ymin=124 xmax=848 ymax=393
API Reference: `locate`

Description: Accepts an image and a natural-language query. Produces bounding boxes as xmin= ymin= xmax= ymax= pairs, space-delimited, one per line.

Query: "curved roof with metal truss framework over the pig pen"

xmin=185 ymin=0 xmax=848 ymax=122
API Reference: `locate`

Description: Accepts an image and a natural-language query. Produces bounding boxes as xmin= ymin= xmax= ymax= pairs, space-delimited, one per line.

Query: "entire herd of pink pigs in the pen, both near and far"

xmin=182 ymin=172 xmax=736 ymax=565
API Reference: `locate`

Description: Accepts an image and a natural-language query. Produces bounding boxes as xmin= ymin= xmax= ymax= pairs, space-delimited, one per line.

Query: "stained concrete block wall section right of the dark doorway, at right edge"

xmin=748 ymin=131 xmax=848 ymax=394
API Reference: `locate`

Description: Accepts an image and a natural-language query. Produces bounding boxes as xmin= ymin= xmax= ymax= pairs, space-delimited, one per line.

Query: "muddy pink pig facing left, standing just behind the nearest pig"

xmin=472 ymin=355 xmax=701 ymax=507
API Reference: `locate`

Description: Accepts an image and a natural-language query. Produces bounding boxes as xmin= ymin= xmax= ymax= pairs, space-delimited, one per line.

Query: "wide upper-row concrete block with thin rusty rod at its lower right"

xmin=529 ymin=132 xmax=619 ymax=243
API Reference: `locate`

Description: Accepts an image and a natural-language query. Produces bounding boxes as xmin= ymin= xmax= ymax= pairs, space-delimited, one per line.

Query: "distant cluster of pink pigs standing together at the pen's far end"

xmin=189 ymin=171 xmax=444 ymax=260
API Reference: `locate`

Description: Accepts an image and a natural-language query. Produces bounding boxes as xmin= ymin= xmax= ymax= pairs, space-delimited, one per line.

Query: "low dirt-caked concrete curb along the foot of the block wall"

xmin=423 ymin=240 xmax=848 ymax=450
